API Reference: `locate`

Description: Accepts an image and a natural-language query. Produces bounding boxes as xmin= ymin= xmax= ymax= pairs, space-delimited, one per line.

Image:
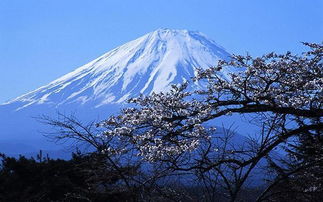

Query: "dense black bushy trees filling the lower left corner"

xmin=0 ymin=153 xmax=135 ymax=202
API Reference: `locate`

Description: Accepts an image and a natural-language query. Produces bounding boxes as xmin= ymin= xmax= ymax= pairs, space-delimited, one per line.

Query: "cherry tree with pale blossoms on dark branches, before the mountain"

xmin=45 ymin=43 xmax=323 ymax=201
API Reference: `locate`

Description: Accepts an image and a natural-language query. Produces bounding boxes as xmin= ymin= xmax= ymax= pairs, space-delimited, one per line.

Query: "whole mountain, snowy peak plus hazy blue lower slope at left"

xmin=0 ymin=29 xmax=231 ymax=155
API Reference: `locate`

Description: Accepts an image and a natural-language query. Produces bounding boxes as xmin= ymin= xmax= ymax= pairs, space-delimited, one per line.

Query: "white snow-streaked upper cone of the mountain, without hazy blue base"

xmin=6 ymin=29 xmax=230 ymax=110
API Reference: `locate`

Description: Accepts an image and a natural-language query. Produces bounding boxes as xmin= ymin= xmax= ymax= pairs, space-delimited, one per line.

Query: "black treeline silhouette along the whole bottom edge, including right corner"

xmin=0 ymin=146 xmax=323 ymax=202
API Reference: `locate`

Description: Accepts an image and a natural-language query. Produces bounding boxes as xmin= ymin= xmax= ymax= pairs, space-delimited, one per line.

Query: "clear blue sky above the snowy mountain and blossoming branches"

xmin=0 ymin=0 xmax=323 ymax=103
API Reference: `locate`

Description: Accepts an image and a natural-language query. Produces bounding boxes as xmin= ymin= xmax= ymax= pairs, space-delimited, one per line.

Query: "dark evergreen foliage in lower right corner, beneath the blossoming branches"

xmin=260 ymin=119 xmax=323 ymax=202
